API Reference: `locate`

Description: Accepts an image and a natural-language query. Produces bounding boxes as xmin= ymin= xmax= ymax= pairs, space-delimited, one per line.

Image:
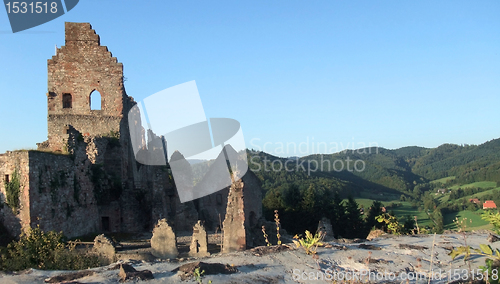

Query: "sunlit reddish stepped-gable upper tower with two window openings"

xmin=44 ymin=23 xmax=128 ymax=151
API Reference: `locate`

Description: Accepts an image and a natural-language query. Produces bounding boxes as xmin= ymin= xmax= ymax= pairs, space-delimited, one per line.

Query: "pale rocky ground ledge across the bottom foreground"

xmin=0 ymin=232 xmax=500 ymax=284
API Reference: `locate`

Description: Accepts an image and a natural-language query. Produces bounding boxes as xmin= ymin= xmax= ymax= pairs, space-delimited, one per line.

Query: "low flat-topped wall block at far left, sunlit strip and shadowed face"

xmin=0 ymin=151 xmax=98 ymax=237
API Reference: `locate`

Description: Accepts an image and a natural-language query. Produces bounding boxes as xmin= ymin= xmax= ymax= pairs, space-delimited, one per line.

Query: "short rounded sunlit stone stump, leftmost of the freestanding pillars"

xmin=151 ymin=219 xmax=179 ymax=259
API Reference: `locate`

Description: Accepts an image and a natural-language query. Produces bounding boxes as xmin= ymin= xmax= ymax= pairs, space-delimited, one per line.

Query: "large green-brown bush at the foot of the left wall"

xmin=0 ymin=226 xmax=99 ymax=270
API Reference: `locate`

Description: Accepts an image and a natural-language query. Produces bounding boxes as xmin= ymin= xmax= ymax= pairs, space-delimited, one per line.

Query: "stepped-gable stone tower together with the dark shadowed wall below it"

xmin=42 ymin=23 xmax=162 ymax=235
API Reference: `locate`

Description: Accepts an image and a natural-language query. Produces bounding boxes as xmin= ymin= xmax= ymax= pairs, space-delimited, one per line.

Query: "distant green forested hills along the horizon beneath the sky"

xmin=248 ymin=139 xmax=500 ymax=198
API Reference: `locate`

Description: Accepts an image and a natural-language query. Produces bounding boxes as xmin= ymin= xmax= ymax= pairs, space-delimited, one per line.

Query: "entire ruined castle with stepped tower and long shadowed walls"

xmin=0 ymin=23 xmax=262 ymax=245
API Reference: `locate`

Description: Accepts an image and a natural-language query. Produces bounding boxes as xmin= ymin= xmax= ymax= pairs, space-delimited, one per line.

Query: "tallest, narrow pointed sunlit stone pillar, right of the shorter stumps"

xmin=222 ymin=179 xmax=246 ymax=253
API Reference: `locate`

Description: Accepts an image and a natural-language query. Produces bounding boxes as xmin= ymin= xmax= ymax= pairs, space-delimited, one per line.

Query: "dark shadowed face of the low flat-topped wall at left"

xmin=29 ymin=151 xmax=99 ymax=237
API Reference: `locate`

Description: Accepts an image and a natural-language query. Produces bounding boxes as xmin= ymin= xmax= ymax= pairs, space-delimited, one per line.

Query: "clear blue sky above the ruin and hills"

xmin=0 ymin=0 xmax=500 ymax=156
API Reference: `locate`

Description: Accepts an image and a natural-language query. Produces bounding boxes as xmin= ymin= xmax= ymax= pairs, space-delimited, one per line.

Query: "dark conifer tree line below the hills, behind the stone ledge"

xmin=263 ymin=184 xmax=424 ymax=239
